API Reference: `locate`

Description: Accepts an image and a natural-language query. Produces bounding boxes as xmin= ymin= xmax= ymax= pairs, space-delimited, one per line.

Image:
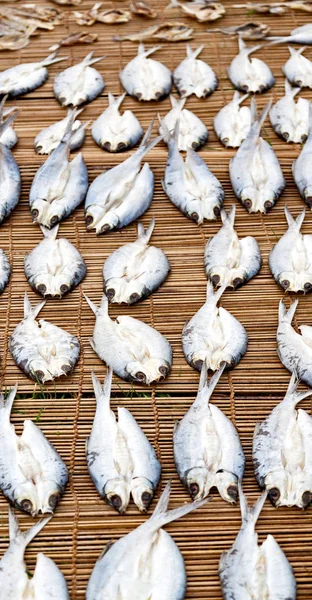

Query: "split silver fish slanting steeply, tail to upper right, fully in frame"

xmin=85 ymin=122 xmax=161 ymax=235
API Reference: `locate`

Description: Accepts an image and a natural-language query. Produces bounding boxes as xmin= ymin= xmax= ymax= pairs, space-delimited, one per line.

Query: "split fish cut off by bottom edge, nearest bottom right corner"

xmin=219 ymin=486 xmax=296 ymax=600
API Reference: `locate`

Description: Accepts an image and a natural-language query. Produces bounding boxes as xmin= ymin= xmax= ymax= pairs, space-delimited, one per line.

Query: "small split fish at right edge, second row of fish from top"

xmin=269 ymin=79 xmax=310 ymax=144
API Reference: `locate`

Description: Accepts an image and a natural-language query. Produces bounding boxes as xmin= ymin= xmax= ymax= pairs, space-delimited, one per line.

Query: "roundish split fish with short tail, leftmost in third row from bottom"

xmin=9 ymin=294 xmax=80 ymax=383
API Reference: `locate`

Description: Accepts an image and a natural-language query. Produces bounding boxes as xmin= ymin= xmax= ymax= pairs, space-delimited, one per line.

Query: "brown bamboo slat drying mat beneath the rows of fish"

xmin=0 ymin=0 xmax=312 ymax=600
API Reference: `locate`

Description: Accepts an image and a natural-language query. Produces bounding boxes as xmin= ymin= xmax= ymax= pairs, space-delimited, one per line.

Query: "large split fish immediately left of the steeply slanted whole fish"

xmin=29 ymin=111 xmax=88 ymax=229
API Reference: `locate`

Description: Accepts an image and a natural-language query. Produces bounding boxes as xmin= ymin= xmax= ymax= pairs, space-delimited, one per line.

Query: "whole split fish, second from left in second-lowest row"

xmin=86 ymin=369 xmax=161 ymax=514
